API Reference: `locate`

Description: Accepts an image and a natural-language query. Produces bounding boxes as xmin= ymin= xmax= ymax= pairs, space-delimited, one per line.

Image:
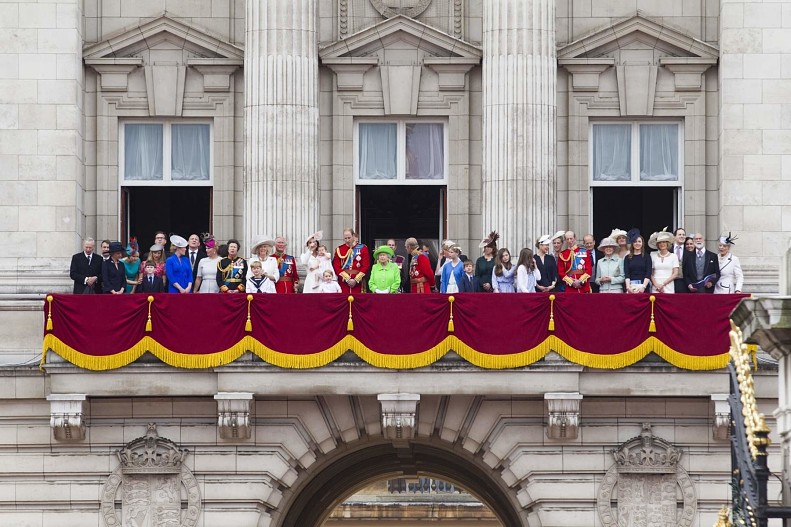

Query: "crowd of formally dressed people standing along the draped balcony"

xmin=70 ymin=224 xmax=743 ymax=294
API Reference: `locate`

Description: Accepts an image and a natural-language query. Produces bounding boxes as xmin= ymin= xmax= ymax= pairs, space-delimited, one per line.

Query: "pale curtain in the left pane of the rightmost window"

xmin=593 ymin=124 xmax=632 ymax=181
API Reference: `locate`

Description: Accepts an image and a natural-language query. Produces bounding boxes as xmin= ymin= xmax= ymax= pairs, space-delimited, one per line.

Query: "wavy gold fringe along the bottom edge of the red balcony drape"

xmin=39 ymin=333 xmax=729 ymax=371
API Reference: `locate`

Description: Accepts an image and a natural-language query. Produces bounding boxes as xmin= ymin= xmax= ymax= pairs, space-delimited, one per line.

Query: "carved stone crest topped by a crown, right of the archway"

xmin=596 ymin=423 xmax=697 ymax=527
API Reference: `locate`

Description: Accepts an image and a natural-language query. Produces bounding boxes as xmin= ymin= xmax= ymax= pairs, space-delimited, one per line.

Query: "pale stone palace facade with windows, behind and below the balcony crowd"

xmin=0 ymin=0 xmax=791 ymax=527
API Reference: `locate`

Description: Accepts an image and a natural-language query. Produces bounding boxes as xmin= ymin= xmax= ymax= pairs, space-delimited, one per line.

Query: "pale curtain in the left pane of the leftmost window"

xmin=124 ymin=124 xmax=162 ymax=181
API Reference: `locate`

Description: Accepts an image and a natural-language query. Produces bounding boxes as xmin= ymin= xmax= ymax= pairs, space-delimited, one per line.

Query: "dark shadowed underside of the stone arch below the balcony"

xmin=279 ymin=443 xmax=524 ymax=527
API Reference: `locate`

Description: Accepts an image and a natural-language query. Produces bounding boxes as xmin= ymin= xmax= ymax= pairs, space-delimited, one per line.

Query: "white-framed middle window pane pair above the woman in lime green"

xmin=354 ymin=121 xmax=448 ymax=185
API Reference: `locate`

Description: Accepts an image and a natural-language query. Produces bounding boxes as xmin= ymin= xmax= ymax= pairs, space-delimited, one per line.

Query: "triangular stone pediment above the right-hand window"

xmin=558 ymin=12 xmax=719 ymax=61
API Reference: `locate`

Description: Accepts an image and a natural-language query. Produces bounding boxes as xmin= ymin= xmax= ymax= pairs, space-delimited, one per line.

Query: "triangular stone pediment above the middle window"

xmin=319 ymin=15 xmax=483 ymax=60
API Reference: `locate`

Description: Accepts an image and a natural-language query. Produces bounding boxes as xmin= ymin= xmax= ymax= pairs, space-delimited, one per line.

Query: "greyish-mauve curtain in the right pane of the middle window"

xmin=406 ymin=123 xmax=445 ymax=179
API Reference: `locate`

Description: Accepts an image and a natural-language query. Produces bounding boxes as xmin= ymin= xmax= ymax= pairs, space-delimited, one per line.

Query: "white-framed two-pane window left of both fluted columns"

xmin=118 ymin=121 xmax=213 ymax=186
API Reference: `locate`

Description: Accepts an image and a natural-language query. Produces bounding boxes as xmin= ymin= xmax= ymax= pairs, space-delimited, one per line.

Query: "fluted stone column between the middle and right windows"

xmin=482 ymin=0 xmax=559 ymax=253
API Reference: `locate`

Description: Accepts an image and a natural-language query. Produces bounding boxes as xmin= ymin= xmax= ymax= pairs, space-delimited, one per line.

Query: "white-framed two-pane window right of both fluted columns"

xmin=590 ymin=121 xmax=683 ymax=186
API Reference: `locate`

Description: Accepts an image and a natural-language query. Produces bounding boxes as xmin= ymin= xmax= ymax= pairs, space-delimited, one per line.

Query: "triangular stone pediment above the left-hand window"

xmin=83 ymin=15 xmax=244 ymax=64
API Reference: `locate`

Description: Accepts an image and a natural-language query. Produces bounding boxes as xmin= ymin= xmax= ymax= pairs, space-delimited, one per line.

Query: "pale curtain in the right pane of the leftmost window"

xmin=170 ymin=124 xmax=210 ymax=181
